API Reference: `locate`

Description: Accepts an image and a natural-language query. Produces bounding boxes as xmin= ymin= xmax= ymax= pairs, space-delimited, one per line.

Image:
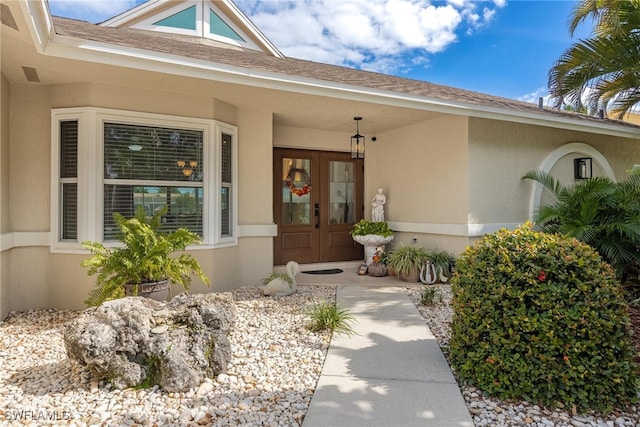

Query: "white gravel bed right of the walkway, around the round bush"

xmin=407 ymin=285 xmax=640 ymax=427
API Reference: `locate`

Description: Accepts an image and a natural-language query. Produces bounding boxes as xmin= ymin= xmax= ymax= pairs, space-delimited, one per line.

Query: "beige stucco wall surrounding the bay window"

xmin=0 ymin=83 xmax=273 ymax=317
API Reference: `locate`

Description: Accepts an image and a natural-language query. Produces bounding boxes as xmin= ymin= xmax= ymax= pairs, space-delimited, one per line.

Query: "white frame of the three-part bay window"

xmin=50 ymin=107 xmax=238 ymax=253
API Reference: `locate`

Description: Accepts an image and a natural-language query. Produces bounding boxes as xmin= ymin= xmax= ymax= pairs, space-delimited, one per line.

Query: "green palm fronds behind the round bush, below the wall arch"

xmin=523 ymin=171 xmax=640 ymax=281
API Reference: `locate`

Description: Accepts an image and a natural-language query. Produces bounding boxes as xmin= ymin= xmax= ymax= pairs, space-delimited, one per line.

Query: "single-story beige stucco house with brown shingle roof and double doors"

xmin=0 ymin=0 xmax=640 ymax=318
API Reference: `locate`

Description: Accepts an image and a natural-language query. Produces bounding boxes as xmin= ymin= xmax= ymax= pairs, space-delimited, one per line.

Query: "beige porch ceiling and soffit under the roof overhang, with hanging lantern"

xmin=0 ymin=2 xmax=442 ymax=136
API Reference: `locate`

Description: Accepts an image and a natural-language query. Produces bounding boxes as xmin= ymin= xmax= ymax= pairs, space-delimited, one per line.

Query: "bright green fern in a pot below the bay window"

xmin=81 ymin=206 xmax=210 ymax=306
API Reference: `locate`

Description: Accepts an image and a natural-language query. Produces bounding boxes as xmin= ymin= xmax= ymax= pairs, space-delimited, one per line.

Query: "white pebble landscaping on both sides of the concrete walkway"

xmin=0 ymin=285 xmax=640 ymax=427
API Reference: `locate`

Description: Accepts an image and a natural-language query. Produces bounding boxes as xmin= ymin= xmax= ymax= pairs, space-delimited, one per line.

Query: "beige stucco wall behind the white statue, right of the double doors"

xmin=365 ymin=115 xmax=468 ymax=252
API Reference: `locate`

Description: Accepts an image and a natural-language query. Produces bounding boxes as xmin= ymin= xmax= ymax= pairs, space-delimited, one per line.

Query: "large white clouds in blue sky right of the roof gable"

xmin=235 ymin=0 xmax=506 ymax=74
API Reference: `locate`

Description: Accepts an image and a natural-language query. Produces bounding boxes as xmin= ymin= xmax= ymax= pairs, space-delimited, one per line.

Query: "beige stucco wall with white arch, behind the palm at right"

xmin=468 ymin=118 xmax=640 ymax=224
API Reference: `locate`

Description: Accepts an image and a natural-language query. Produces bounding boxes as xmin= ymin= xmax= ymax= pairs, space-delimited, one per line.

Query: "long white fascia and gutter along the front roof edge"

xmin=21 ymin=6 xmax=640 ymax=138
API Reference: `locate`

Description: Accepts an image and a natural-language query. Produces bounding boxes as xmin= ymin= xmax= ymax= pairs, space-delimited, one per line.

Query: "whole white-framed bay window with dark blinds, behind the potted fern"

xmin=51 ymin=108 xmax=237 ymax=250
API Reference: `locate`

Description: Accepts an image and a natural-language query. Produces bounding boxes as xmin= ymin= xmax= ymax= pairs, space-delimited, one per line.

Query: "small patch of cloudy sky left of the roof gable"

xmin=49 ymin=0 xmax=140 ymax=23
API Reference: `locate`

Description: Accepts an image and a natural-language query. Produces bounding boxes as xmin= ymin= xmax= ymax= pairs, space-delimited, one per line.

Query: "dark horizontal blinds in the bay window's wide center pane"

xmin=103 ymin=123 xmax=204 ymax=240
